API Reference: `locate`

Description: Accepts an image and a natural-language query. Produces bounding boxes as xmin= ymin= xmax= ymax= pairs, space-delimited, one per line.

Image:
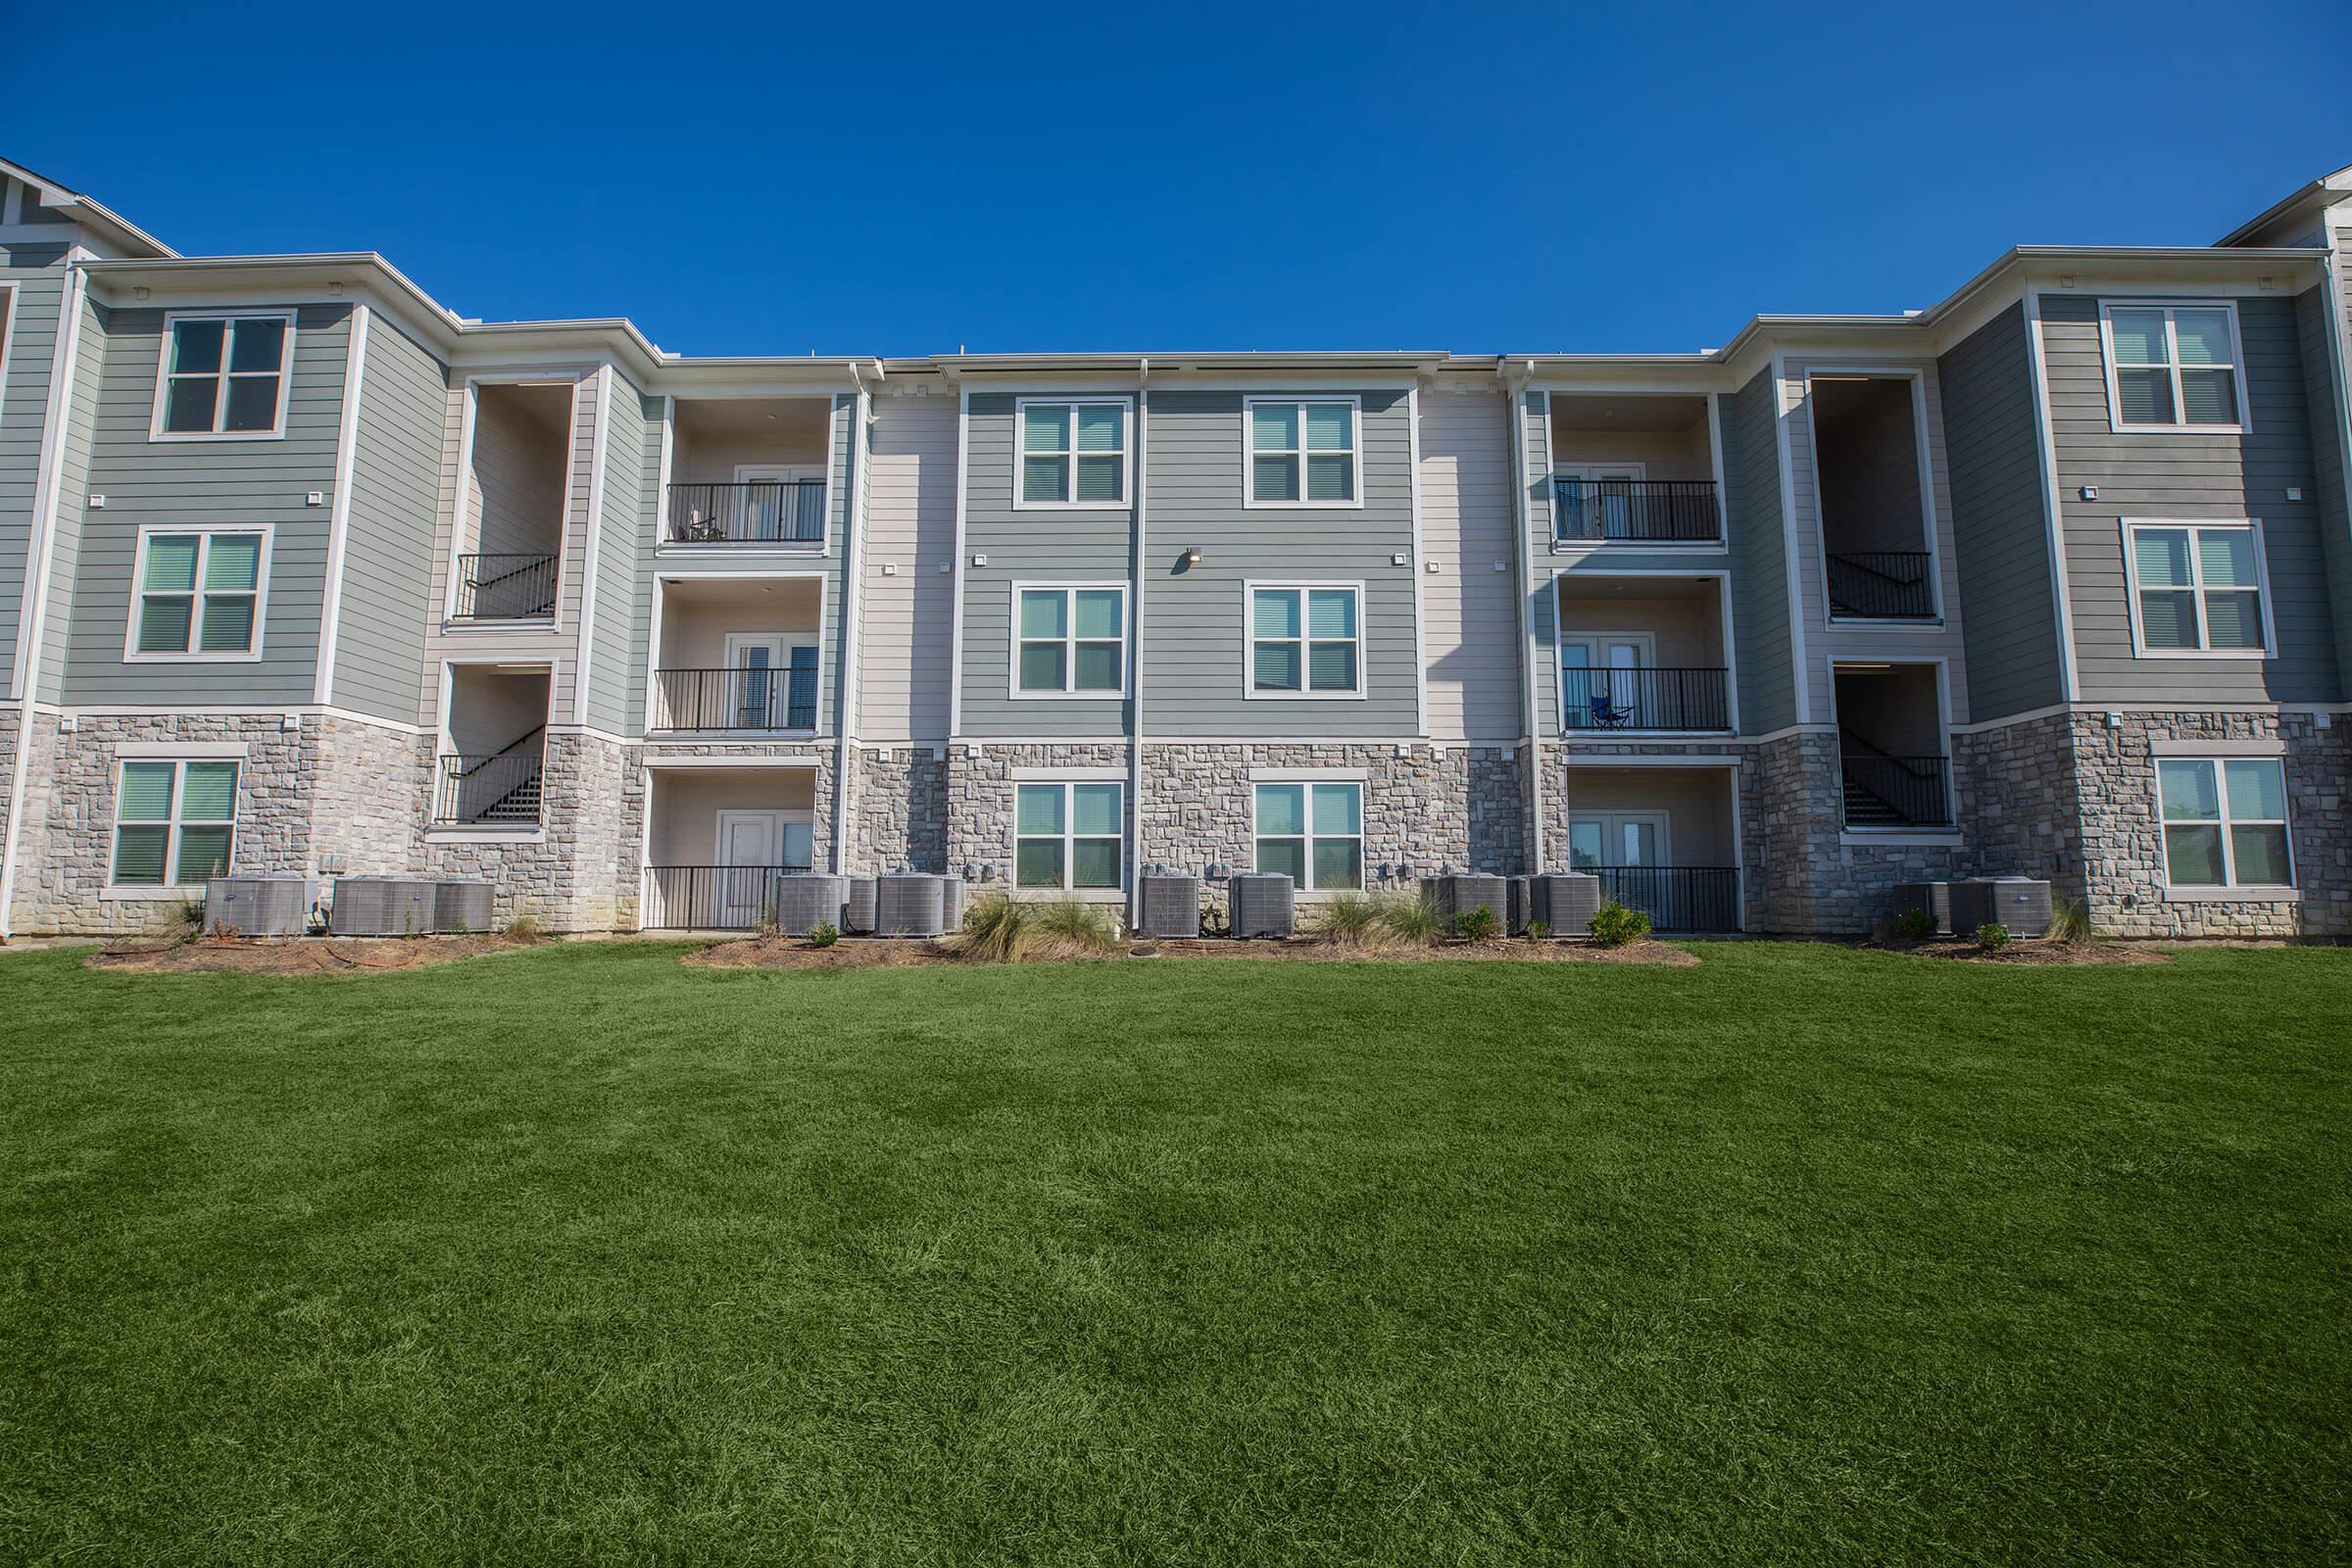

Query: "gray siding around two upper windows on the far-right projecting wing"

xmin=2041 ymin=294 xmax=2342 ymax=703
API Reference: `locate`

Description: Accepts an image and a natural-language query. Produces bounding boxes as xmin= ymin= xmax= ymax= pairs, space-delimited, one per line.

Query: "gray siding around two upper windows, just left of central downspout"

xmin=962 ymin=393 xmax=1133 ymax=736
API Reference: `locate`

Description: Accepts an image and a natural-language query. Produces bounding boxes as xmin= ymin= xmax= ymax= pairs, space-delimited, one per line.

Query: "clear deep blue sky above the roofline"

xmin=0 ymin=0 xmax=2352 ymax=355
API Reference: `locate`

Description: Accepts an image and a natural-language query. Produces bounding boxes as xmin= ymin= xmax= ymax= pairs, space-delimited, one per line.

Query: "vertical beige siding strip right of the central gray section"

xmin=1421 ymin=393 xmax=1519 ymax=741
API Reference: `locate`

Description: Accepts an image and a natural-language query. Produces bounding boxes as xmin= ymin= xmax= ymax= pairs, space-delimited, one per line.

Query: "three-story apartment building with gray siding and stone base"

xmin=0 ymin=163 xmax=2352 ymax=936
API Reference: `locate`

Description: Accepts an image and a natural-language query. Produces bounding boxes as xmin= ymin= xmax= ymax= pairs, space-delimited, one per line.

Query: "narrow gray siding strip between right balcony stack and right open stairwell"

xmin=1715 ymin=369 xmax=1797 ymax=736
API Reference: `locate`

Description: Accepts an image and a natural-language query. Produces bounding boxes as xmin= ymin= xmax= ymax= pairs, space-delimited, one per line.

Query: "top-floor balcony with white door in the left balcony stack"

xmin=661 ymin=397 xmax=833 ymax=550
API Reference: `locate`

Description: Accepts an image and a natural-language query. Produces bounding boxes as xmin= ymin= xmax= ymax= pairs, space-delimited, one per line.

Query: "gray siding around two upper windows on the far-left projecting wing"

xmin=61 ymin=306 xmax=351 ymax=703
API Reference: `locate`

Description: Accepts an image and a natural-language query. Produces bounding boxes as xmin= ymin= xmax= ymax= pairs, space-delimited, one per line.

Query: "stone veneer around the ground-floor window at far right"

xmin=2072 ymin=712 xmax=2352 ymax=936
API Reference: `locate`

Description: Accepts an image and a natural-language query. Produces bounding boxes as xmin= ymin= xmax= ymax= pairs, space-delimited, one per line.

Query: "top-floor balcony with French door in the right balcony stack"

xmin=1550 ymin=393 xmax=1724 ymax=548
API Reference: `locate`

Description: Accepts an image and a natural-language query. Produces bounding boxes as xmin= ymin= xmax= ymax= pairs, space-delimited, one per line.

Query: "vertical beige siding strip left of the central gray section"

xmin=858 ymin=395 xmax=957 ymax=743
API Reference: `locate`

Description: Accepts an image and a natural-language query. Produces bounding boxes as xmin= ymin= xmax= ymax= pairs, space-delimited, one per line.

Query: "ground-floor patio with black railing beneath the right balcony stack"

xmin=1566 ymin=766 xmax=1740 ymax=933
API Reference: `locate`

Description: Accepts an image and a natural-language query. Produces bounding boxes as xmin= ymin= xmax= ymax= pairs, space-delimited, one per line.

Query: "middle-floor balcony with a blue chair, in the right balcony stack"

xmin=1559 ymin=569 xmax=1734 ymax=736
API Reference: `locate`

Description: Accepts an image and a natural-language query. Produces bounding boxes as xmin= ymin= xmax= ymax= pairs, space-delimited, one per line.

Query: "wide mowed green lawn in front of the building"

xmin=0 ymin=945 xmax=2352 ymax=1568
